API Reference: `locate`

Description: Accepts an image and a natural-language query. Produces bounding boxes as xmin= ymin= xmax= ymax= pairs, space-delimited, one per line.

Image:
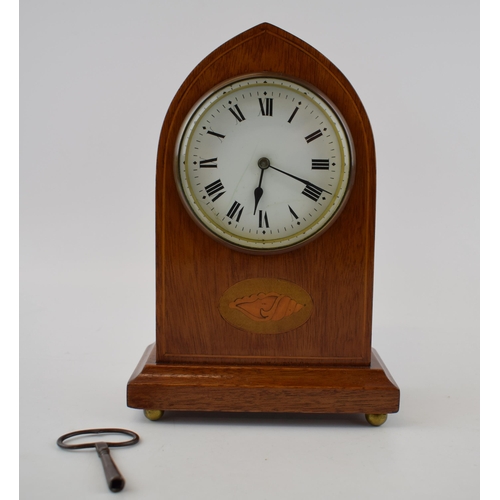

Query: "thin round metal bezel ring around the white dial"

xmin=173 ymin=71 xmax=356 ymax=255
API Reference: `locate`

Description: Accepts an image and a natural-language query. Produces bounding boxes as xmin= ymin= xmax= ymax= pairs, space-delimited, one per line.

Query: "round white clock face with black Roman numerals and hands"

xmin=175 ymin=75 xmax=354 ymax=252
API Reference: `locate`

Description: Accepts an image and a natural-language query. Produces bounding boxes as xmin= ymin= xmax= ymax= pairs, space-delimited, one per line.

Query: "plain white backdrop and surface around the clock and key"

xmin=20 ymin=0 xmax=479 ymax=500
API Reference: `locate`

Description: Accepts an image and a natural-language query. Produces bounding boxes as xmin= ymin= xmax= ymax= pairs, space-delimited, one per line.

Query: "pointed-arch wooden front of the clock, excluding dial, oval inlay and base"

xmin=156 ymin=24 xmax=375 ymax=366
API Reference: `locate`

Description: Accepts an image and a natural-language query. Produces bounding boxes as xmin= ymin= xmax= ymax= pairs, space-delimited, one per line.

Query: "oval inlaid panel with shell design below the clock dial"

xmin=219 ymin=278 xmax=313 ymax=334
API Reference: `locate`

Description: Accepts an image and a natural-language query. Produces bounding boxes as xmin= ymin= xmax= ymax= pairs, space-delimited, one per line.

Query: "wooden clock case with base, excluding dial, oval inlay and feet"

xmin=127 ymin=24 xmax=399 ymax=420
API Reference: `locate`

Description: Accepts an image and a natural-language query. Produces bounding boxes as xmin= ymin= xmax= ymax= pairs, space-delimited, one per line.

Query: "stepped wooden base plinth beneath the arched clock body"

xmin=127 ymin=344 xmax=399 ymax=414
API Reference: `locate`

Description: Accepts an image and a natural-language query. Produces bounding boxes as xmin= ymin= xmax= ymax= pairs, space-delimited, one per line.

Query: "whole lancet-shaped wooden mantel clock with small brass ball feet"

xmin=127 ymin=24 xmax=399 ymax=425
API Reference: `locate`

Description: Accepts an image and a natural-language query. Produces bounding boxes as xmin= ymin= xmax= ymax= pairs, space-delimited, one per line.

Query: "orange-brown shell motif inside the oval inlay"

xmin=229 ymin=292 xmax=304 ymax=321
